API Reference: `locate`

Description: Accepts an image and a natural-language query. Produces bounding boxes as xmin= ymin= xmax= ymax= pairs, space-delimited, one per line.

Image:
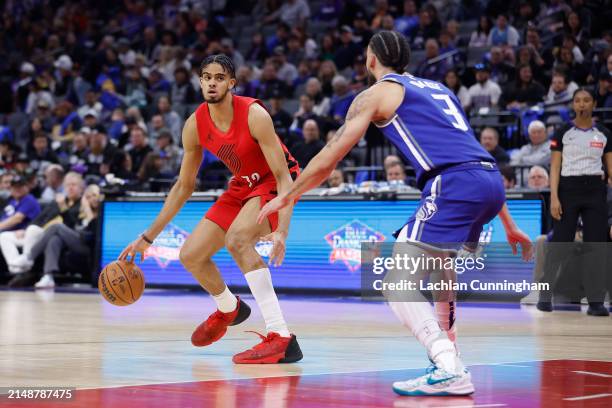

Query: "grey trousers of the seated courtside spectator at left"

xmin=31 ymin=224 xmax=89 ymax=274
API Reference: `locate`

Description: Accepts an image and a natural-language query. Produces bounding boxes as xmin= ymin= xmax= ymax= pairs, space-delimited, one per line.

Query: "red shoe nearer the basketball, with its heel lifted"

xmin=191 ymin=296 xmax=251 ymax=347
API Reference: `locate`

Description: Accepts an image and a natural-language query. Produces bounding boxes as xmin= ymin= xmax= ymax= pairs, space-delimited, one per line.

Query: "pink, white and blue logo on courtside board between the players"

xmin=325 ymin=220 xmax=385 ymax=273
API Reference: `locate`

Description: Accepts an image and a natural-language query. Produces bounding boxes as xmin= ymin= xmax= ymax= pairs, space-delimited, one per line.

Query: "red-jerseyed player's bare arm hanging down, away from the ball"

xmin=249 ymin=103 xmax=293 ymax=265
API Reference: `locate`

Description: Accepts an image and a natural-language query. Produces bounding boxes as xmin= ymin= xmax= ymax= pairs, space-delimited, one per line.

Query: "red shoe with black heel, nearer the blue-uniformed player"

xmin=232 ymin=332 xmax=303 ymax=364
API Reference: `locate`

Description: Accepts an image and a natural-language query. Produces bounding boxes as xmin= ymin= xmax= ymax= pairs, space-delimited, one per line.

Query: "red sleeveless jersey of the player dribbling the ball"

xmin=195 ymin=95 xmax=299 ymax=187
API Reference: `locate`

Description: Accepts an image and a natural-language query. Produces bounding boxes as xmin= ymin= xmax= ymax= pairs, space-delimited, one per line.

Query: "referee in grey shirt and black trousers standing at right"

xmin=538 ymin=88 xmax=612 ymax=316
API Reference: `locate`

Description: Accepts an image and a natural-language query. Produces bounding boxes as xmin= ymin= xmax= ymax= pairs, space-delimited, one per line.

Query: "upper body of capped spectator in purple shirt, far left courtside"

xmin=0 ymin=175 xmax=40 ymax=231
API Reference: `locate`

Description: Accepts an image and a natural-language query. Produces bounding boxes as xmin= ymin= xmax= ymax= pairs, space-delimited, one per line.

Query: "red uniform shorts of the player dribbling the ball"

xmin=205 ymin=177 xmax=278 ymax=232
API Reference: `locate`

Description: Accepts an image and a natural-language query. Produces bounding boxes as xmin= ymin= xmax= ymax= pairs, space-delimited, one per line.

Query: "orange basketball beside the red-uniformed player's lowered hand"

xmin=98 ymin=261 xmax=144 ymax=306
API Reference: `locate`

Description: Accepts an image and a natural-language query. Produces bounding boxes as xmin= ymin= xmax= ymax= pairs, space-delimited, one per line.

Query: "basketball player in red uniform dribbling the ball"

xmin=119 ymin=55 xmax=302 ymax=364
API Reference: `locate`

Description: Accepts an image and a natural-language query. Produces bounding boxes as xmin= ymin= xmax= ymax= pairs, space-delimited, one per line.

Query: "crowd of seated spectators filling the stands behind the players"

xmin=0 ymin=0 xmax=612 ymax=283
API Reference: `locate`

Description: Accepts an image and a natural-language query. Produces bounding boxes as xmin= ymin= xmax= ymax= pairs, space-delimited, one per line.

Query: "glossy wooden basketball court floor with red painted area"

xmin=0 ymin=291 xmax=612 ymax=408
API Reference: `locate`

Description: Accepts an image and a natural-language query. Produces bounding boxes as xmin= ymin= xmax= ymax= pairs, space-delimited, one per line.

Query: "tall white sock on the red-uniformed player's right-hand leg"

xmin=244 ymin=268 xmax=291 ymax=337
